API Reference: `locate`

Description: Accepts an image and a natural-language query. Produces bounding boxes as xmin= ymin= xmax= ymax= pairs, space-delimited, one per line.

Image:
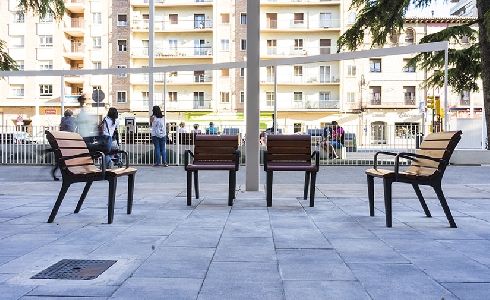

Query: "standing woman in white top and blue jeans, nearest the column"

xmin=150 ymin=105 xmax=168 ymax=167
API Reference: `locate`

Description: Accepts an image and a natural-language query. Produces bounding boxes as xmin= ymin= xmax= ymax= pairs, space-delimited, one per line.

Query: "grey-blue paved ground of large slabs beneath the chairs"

xmin=0 ymin=165 xmax=490 ymax=300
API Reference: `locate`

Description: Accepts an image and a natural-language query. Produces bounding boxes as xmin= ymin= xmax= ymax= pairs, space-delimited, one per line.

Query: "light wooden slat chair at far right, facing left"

xmin=366 ymin=131 xmax=462 ymax=227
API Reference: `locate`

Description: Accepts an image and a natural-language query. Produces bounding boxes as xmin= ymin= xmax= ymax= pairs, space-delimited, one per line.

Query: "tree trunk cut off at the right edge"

xmin=476 ymin=0 xmax=490 ymax=150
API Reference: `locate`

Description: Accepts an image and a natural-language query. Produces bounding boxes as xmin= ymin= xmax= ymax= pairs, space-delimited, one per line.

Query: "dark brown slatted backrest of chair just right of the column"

xmin=267 ymin=134 xmax=311 ymax=164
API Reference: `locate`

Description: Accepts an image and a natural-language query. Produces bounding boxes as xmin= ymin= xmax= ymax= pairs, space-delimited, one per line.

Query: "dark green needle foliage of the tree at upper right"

xmin=337 ymin=0 xmax=490 ymax=92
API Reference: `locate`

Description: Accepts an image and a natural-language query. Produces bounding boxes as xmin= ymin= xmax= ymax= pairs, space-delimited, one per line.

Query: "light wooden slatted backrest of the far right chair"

xmin=407 ymin=130 xmax=462 ymax=175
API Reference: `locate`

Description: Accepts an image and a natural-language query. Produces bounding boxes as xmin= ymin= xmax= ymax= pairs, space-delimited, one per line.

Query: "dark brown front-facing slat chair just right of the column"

xmin=264 ymin=134 xmax=320 ymax=207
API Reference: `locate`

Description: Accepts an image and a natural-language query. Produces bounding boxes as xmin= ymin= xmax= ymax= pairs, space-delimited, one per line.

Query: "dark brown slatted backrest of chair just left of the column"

xmin=193 ymin=134 xmax=239 ymax=162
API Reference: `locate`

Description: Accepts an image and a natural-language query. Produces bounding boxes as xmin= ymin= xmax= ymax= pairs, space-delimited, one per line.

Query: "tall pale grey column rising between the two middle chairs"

xmin=245 ymin=0 xmax=260 ymax=191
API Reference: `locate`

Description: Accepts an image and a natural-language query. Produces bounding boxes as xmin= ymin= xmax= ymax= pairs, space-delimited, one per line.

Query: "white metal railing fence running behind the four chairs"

xmin=0 ymin=124 xmax=422 ymax=165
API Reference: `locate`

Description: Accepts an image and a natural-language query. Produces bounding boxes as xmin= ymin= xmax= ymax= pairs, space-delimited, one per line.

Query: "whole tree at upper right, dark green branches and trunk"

xmin=337 ymin=0 xmax=490 ymax=149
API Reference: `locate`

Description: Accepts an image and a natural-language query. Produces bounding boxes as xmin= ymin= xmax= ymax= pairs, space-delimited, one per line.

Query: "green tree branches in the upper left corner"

xmin=0 ymin=0 xmax=65 ymax=71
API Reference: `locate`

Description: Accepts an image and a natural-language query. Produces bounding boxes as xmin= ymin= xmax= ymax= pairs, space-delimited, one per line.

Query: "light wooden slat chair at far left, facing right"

xmin=46 ymin=131 xmax=136 ymax=224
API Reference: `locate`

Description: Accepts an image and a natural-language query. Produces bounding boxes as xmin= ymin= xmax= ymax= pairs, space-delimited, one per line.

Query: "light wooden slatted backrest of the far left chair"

xmin=46 ymin=130 xmax=100 ymax=174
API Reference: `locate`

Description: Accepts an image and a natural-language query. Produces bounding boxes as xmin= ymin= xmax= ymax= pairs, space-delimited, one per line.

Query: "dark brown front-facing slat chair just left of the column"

xmin=184 ymin=134 xmax=240 ymax=206
